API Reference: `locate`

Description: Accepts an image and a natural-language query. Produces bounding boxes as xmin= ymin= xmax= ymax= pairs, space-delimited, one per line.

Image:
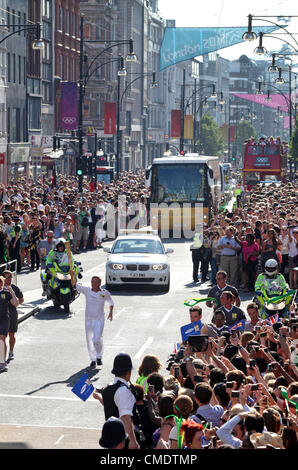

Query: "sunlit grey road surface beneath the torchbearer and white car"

xmin=0 ymin=235 xmax=254 ymax=449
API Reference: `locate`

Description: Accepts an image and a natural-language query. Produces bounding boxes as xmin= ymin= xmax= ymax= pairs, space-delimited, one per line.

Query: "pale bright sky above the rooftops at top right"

xmin=158 ymin=0 xmax=298 ymax=63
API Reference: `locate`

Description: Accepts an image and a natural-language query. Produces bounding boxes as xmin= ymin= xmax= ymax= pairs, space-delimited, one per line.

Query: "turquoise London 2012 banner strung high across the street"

xmin=159 ymin=26 xmax=279 ymax=70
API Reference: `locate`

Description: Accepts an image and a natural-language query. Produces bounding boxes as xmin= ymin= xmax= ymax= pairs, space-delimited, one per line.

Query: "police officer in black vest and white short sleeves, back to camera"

xmin=93 ymin=353 xmax=140 ymax=449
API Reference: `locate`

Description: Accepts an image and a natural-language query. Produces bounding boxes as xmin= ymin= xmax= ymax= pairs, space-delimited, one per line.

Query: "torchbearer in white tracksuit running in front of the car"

xmin=76 ymin=276 xmax=114 ymax=367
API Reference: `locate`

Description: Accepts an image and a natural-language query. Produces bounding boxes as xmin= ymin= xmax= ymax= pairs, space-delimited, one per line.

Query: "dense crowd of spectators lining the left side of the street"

xmin=0 ymin=170 xmax=147 ymax=273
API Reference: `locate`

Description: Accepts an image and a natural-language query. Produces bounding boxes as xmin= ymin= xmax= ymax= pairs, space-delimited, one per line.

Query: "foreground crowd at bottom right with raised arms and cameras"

xmin=98 ymin=296 xmax=298 ymax=449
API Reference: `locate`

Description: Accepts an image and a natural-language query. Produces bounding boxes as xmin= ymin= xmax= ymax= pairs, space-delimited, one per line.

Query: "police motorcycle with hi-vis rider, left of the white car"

xmin=41 ymin=238 xmax=83 ymax=313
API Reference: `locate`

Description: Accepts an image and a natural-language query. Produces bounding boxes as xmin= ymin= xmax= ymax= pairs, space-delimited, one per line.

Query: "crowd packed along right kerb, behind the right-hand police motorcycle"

xmin=196 ymin=183 xmax=298 ymax=292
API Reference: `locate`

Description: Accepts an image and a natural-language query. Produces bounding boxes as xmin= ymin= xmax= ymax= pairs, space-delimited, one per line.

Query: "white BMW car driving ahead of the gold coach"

xmin=104 ymin=232 xmax=173 ymax=292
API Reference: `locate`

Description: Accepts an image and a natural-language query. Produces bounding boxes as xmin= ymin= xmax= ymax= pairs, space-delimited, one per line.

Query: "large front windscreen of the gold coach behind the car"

xmin=151 ymin=163 xmax=205 ymax=203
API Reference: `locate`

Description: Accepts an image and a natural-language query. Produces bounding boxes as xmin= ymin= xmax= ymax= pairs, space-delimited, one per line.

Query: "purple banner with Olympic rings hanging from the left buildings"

xmin=61 ymin=82 xmax=78 ymax=131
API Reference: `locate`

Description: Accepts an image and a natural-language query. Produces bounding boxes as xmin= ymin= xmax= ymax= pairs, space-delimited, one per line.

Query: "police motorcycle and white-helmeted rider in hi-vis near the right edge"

xmin=253 ymin=259 xmax=296 ymax=319
